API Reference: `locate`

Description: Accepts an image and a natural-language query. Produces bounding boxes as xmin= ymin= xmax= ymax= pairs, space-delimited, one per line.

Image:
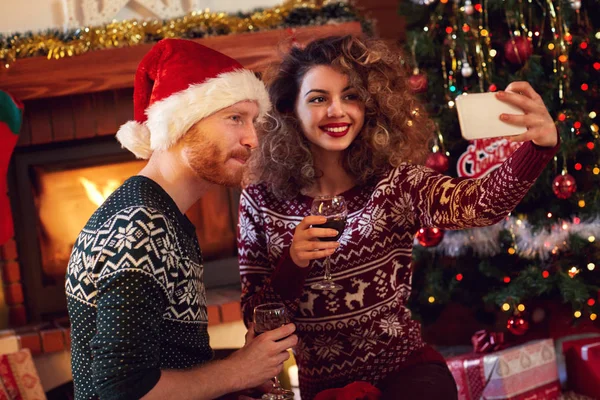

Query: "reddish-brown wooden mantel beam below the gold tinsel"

xmin=0 ymin=22 xmax=361 ymax=100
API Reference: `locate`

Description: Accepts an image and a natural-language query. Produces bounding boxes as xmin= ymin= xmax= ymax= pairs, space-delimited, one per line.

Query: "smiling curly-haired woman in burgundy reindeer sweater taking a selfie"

xmin=238 ymin=36 xmax=558 ymax=400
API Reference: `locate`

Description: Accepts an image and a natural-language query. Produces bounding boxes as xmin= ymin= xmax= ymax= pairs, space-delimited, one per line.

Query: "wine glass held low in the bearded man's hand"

xmin=254 ymin=303 xmax=294 ymax=400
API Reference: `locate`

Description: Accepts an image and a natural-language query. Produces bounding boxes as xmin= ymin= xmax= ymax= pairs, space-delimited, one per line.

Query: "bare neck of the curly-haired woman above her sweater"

xmin=303 ymin=149 xmax=356 ymax=197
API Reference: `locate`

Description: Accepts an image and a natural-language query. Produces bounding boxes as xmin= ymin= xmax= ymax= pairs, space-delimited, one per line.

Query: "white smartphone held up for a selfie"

xmin=456 ymin=92 xmax=527 ymax=140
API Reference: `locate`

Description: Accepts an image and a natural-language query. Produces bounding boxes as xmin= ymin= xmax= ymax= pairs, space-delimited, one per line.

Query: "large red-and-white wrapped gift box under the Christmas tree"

xmin=447 ymin=339 xmax=560 ymax=400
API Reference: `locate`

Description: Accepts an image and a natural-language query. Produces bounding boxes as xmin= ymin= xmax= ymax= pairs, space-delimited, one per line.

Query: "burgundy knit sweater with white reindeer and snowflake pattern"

xmin=238 ymin=142 xmax=558 ymax=400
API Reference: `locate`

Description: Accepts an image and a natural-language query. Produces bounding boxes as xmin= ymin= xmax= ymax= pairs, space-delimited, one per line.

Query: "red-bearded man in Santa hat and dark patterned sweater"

xmin=66 ymin=39 xmax=297 ymax=400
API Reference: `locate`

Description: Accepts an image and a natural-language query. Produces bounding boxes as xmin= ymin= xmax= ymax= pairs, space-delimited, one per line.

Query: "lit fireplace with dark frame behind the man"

xmin=9 ymin=136 xmax=239 ymax=322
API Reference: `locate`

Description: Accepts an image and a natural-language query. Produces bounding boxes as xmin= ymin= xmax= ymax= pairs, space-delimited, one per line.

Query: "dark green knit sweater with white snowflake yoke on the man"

xmin=65 ymin=176 xmax=212 ymax=400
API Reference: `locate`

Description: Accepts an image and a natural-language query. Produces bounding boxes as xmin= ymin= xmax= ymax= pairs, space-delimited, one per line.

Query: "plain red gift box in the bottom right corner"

xmin=563 ymin=337 xmax=600 ymax=398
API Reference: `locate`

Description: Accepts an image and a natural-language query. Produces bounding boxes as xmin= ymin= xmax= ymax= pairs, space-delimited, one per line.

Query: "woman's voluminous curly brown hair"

xmin=246 ymin=36 xmax=434 ymax=198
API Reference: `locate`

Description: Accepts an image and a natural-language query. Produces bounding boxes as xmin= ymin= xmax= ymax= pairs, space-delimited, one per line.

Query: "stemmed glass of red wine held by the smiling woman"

xmin=310 ymin=196 xmax=348 ymax=290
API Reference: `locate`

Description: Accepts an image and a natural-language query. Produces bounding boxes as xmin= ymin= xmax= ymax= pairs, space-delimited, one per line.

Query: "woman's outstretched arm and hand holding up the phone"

xmin=397 ymin=82 xmax=559 ymax=229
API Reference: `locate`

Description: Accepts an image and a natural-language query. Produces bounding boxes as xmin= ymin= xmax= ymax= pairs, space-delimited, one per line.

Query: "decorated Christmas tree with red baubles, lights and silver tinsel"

xmin=400 ymin=0 xmax=600 ymax=334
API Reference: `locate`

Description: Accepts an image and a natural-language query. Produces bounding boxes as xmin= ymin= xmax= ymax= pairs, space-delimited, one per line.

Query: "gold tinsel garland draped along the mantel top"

xmin=0 ymin=0 xmax=358 ymax=68
